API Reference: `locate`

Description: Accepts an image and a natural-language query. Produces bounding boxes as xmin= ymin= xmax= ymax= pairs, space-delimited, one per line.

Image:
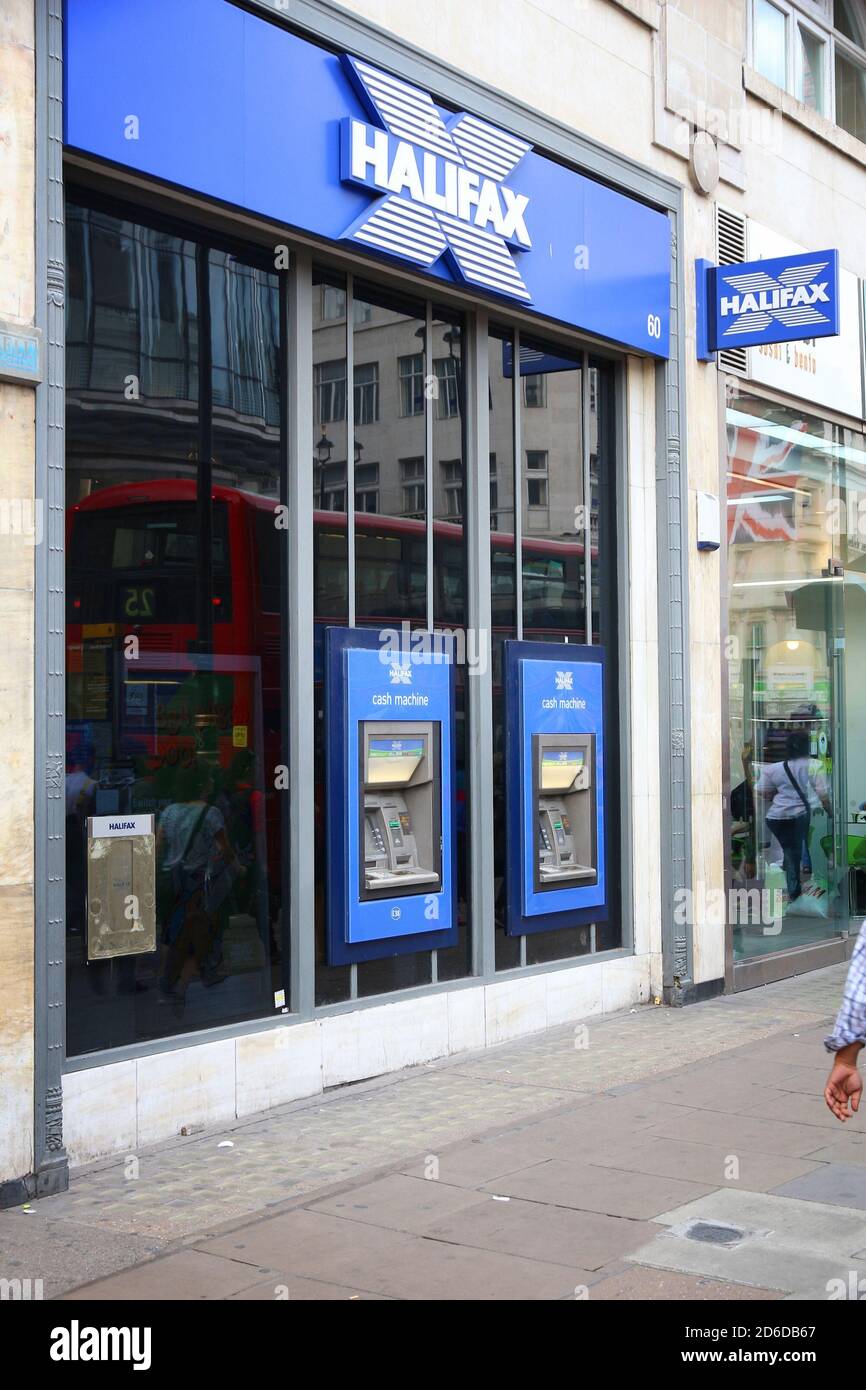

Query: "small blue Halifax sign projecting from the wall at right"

xmin=699 ymin=250 xmax=840 ymax=352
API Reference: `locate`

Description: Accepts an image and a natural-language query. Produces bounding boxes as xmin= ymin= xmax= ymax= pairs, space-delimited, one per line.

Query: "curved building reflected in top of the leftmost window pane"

xmin=67 ymin=204 xmax=279 ymax=500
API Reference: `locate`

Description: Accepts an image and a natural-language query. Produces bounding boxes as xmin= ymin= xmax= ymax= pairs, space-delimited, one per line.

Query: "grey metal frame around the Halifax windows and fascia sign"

xmin=36 ymin=0 xmax=691 ymax=1106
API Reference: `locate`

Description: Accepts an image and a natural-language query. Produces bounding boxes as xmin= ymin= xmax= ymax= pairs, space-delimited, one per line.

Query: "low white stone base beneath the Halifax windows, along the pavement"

xmin=64 ymin=955 xmax=660 ymax=1166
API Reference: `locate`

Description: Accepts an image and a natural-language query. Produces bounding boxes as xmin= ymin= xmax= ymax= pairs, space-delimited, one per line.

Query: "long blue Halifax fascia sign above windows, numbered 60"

xmin=64 ymin=0 xmax=671 ymax=357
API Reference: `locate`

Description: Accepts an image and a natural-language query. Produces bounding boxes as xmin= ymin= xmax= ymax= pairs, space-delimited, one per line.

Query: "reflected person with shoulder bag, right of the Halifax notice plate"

xmin=156 ymin=765 xmax=238 ymax=999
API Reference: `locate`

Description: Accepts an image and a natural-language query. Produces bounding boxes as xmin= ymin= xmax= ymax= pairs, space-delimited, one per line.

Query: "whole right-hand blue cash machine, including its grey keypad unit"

xmin=505 ymin=642 xmax=607 ymax=935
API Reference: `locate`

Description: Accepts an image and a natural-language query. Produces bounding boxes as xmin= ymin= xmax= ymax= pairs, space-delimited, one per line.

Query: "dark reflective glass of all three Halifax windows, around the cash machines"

xmin=67 ymin=195 xmax=621 ymax=1055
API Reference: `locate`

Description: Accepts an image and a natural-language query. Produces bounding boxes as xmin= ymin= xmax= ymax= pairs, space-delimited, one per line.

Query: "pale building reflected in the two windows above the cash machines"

xmin=313 ymin=282 xmax=598 ymax=537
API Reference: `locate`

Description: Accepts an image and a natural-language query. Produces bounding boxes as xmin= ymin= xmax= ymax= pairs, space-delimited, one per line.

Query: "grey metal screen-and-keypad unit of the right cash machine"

xmin=532 ymin=734 xmax=598 ymax=890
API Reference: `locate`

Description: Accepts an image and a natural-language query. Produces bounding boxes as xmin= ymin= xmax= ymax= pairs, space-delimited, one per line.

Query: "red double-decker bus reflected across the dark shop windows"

xmin=67 ymin=478 xmax=584 ymax=928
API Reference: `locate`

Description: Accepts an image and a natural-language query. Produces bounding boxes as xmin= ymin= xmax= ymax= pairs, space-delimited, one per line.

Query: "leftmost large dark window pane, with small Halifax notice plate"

xmin=65 ymin=200 xmax=288 ymax=1056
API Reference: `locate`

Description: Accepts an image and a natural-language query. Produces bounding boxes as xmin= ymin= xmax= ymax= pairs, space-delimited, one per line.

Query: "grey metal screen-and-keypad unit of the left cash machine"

xmin=359 ymin=720 xmax=442 ymax=899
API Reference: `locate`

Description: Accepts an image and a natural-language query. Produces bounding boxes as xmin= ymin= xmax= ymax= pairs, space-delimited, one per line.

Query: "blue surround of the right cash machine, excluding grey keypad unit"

xmin=505 ymin=642 xmax=607 ymax=935
